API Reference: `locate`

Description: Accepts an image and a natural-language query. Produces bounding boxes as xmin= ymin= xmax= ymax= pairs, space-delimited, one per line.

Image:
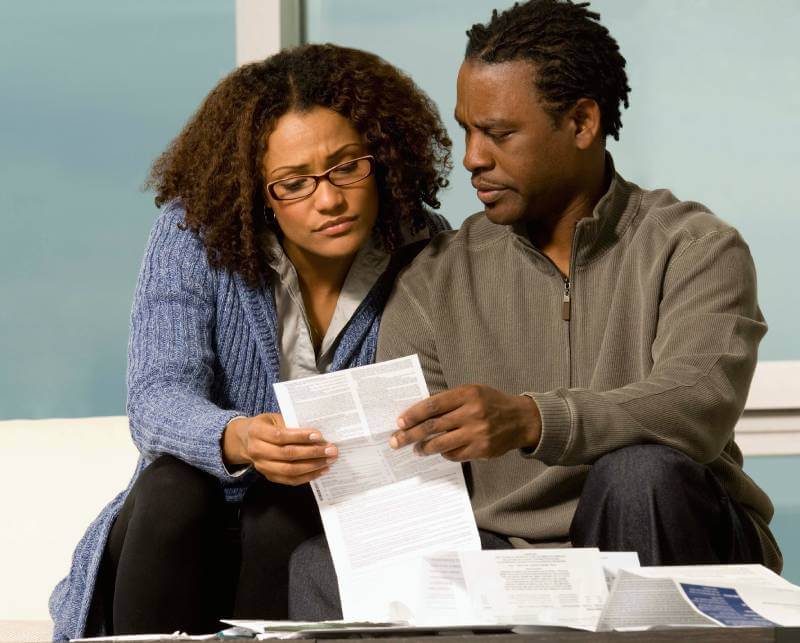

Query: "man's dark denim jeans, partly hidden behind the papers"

xmin=289 ymin=445 xmax=763 ymax=621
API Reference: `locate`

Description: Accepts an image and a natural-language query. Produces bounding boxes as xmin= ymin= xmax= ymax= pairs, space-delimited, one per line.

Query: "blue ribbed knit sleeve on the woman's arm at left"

xmin=128 ymin=206 xmax=240 ymax=481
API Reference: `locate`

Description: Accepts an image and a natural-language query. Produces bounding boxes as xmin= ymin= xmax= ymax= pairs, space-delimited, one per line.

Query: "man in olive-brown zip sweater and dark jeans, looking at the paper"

xmin=290 ymin=0 xmax=782 ymax=618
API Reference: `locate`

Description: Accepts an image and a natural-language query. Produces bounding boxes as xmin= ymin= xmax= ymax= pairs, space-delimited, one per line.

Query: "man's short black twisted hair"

xmin=465 ymin=0 xmax=631 ymax=140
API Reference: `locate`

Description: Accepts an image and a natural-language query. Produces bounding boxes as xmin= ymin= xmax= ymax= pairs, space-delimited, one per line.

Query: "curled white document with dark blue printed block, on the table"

xmin=599 ymin=565 xmax=800 ymax=630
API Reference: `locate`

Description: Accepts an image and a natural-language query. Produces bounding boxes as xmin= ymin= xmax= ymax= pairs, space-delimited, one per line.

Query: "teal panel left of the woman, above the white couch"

xmin=0 ymin=0 xmax=235 ymax=419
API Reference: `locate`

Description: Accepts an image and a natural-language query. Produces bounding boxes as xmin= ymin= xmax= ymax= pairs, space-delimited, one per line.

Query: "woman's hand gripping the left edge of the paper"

xmin=222 ymin=413 xmax=339 ymax=486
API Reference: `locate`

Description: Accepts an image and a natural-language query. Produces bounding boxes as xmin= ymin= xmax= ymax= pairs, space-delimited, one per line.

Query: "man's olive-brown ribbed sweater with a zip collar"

xmin=378 ymin=169 xmax=782 ymax=570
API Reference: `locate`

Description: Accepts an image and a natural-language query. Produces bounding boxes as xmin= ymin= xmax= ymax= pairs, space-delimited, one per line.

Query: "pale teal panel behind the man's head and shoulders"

xmin=306 ymin=0 xmax=800 ymax=360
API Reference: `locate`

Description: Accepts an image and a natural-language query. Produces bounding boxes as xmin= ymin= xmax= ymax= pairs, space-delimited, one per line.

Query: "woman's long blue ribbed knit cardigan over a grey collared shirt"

xmin=50 ymin=203 xmax=449 ymax=640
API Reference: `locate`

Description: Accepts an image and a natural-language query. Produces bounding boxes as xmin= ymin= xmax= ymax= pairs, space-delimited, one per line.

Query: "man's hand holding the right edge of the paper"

xmin=389 ymin=384 xmax=542 ymax=462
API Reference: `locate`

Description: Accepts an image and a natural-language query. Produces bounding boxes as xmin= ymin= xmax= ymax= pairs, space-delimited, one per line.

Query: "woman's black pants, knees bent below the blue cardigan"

xmin=94 ymin=455 xmax=322 ymax=634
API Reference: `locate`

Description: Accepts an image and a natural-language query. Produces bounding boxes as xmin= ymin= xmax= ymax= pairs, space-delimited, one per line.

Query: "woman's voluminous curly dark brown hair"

xmin=145 ymin=44 xmax=451 ymax=284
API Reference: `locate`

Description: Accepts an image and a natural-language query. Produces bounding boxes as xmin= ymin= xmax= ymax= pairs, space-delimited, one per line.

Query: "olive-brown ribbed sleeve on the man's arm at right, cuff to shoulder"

xmin=530 ymin=229 xmax=766 ymax=465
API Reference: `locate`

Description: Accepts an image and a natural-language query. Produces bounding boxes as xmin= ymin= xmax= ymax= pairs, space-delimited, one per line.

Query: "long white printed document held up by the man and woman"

xmin=275 ymin=355 xmax=480 ymax=621
